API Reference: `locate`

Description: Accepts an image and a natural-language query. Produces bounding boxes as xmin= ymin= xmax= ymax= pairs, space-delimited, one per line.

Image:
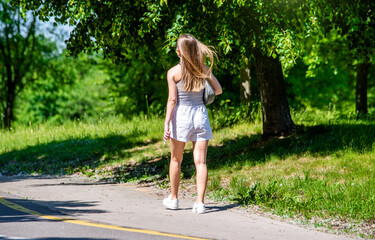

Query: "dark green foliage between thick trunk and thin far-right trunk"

xmin=285 ymin=61 xmax=355 ymax=111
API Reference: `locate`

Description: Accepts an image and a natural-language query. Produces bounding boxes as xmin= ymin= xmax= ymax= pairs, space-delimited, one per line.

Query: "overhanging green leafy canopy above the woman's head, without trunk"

xmin=16 ymin=0 xmax=306 ymax=69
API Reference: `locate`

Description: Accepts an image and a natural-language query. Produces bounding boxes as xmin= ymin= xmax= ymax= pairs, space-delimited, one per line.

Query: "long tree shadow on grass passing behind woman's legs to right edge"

xmin=92 ymin=124 xmax=375 ymax=183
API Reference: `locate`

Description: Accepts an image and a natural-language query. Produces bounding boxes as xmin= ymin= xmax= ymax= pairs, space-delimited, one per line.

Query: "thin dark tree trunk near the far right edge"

xmin=355 ymin=63 xmax=369 ymax=115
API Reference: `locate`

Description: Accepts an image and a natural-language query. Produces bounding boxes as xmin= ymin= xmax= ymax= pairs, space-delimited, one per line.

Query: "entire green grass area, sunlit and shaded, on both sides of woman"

xmin=0 ymin=110 xmax=375 ymax=238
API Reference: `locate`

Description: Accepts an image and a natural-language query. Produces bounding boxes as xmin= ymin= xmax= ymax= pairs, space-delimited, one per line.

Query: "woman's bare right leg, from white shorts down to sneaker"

xmin=193 ymin=141 xmax=208 ymax=203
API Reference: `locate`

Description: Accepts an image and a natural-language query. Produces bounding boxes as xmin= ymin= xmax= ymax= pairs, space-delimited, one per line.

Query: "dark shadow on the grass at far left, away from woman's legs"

xmin=0 ymin=132 xmax=156 ymax=175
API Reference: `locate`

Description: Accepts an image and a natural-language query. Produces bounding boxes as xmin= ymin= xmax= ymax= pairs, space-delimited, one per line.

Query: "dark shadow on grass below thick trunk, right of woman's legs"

xmin=204 ymin=124 xmax=375 ymax=172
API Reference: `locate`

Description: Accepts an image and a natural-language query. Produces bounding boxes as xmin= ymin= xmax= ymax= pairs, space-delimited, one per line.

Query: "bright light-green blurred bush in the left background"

xmin=16 ymin=54 xmax=114 ymax=124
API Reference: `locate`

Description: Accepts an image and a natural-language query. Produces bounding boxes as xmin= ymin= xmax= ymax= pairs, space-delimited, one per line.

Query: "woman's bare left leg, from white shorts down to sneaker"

xmin=169 ymin=138 xmax=186 ymax=200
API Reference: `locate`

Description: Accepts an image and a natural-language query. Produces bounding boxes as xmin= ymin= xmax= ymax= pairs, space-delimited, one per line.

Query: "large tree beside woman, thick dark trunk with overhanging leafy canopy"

xmin=20 ymin=0 xmax=312 ymax=136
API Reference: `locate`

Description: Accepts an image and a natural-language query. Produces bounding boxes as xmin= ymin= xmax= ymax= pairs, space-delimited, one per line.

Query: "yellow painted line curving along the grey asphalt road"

xmin=0 ymin=196 xmax=209 ymax=240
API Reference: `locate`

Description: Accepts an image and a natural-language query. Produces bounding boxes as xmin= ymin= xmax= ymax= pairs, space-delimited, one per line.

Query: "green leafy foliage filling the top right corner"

xmin=304 ymin=0 xmax=375 ymax=79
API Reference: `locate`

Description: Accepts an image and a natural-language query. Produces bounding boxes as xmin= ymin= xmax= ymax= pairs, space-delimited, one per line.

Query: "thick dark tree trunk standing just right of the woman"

xmin=254 ymin=48 xmax=295 ymax=137
